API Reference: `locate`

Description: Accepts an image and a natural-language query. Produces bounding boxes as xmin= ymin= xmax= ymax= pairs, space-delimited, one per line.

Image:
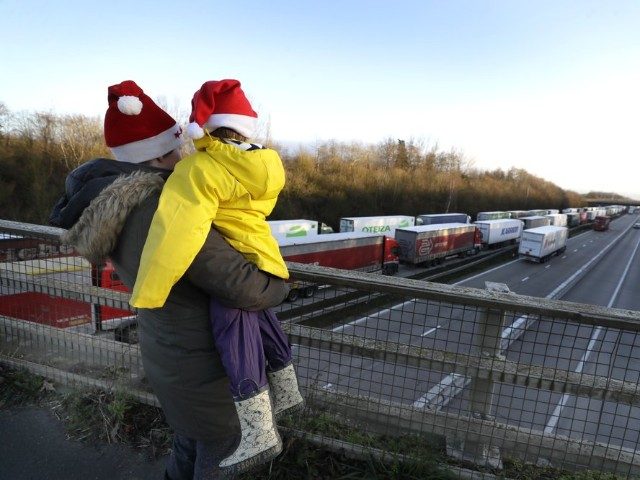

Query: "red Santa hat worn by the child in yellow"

xmin=186 ymin=80 xmax=258 ymax=139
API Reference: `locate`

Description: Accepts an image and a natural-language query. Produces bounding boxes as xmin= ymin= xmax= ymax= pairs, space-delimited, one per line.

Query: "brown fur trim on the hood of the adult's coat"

xmin=62 ymin=171 xmax=164 ymax=263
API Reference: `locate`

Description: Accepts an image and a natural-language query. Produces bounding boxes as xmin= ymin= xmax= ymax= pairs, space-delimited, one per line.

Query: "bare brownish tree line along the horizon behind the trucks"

xmin=0 ymin=103 xmax=608 ymax=231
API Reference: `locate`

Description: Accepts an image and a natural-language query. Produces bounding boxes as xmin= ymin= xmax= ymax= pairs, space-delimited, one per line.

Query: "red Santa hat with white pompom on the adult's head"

xmin=104 ymin=80 xmax=182 ymax=163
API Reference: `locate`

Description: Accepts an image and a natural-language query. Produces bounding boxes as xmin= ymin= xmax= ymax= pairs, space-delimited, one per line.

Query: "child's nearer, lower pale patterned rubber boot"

xmin=219 ymin=390 xmax=282 ymax=475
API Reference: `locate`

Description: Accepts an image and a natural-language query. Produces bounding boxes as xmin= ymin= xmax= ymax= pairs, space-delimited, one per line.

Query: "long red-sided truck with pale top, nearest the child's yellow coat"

xmin=278 ymin=232 xmax=399 ymax=302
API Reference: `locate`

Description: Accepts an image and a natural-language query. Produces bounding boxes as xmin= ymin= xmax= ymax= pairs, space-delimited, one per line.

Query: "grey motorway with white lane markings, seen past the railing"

xmin=297 ymin=215 xmax=640 ymax=458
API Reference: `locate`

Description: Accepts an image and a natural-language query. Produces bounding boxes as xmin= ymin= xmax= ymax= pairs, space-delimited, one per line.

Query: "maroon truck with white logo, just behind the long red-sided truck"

xmin=396 ymin=223 xmax=481 ymax=266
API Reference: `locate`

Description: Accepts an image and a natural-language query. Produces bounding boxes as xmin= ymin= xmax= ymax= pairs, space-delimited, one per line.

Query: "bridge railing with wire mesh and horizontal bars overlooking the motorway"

xmin=0 ymin=221 xmax=640 ymax=478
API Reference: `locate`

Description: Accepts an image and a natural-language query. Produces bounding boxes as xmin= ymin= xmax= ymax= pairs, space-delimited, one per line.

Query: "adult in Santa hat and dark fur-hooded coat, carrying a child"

xmin=51 ymin=81 xmax=287 ymax=480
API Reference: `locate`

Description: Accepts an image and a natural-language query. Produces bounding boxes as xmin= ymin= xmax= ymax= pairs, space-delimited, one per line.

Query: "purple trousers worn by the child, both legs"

xmin=209 ymin=298 xmax=292 ymax=400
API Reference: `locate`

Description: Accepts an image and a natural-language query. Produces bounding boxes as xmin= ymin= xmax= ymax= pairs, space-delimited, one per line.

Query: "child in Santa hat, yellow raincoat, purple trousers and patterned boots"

xmin=131 ymin=80 xmax=303 ymax=473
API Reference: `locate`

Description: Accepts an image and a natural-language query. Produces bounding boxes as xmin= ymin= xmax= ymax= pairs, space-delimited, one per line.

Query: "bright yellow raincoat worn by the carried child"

xmin=130 ymin=136 xmax=289 ymax=308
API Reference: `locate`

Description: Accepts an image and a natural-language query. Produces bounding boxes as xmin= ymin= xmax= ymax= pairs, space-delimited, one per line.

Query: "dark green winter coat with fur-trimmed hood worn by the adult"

xmin=66 ymin=173 xmax=287 ymax=441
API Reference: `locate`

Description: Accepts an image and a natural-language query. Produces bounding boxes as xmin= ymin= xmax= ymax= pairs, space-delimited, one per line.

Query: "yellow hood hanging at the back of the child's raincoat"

xmin=194 ymin=137 xmax=285 ymax=200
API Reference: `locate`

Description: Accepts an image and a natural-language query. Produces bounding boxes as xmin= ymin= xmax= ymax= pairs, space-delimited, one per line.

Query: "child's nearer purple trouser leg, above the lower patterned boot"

xmin=209 ymin=298 xmax=267 ymax=400
